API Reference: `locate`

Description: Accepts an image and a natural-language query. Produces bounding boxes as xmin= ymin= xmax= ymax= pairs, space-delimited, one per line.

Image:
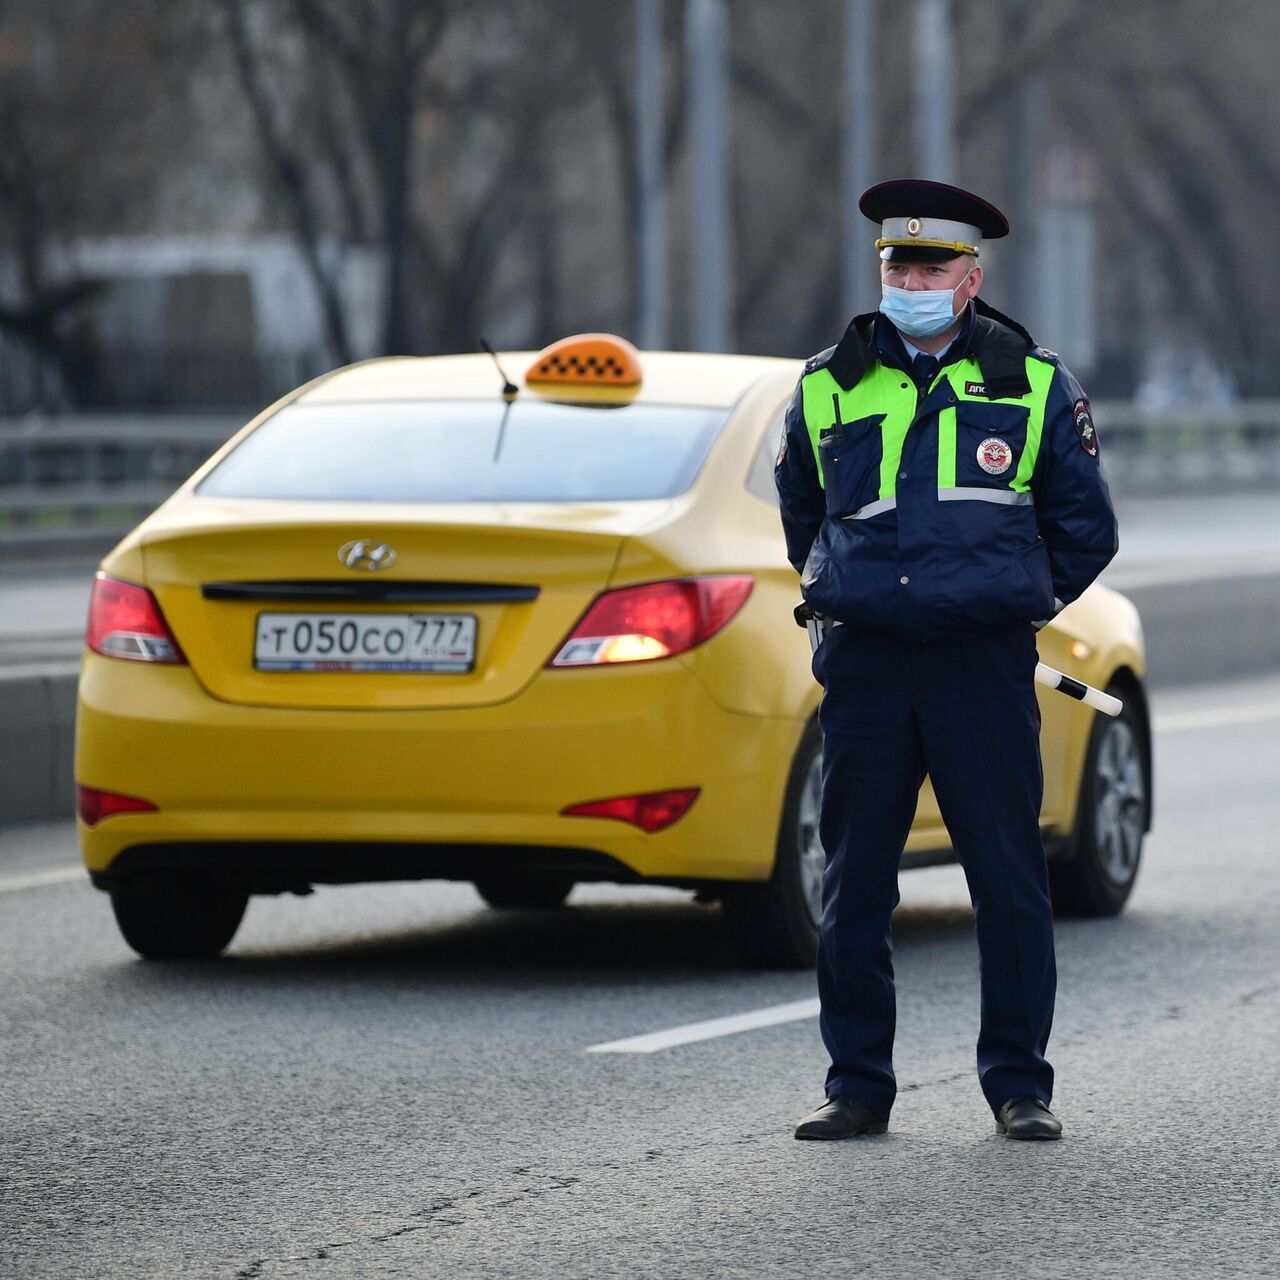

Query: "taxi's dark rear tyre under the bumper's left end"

xmin=111 ymin=882 xmax=248 ymax=960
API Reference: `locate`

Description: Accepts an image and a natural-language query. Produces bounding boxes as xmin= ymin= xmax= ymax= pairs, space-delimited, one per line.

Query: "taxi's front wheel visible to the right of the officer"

xmin=1048 ymin=685 xmax=1151 ymax=916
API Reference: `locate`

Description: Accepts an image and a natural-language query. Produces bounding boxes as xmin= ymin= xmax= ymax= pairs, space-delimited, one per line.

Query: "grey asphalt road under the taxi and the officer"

xmin=0 ymin=678 xmax=1280 ymax=1280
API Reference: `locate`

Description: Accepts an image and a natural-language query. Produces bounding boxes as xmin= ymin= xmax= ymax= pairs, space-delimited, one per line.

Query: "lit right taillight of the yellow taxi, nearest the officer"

xmin=548 ymin=576 xmax=754 ymax=667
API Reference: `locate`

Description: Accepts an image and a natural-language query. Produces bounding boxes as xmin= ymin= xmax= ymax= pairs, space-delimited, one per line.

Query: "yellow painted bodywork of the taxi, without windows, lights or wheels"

xmin=76 ymin=340 xmax=1144 ymax=962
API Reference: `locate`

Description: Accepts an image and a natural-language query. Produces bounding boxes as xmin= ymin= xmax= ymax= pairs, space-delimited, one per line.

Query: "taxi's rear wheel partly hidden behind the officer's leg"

xmin=722 ymin=721 xmax=827 ymax=969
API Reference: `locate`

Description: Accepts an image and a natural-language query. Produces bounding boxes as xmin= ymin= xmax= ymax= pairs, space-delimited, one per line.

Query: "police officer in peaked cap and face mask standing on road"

xmin=774 ymin=180 xmax=1116 ymax=1138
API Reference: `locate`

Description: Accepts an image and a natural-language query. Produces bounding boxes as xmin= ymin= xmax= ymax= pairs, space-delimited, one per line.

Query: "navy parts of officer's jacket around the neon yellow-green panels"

xmin=774 ymin=302 xmax=1117 ymax=641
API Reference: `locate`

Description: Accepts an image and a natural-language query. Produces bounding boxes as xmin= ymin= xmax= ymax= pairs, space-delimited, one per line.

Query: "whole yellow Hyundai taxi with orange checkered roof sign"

xmin=76 ymin=334 xmax=1151 ymax=964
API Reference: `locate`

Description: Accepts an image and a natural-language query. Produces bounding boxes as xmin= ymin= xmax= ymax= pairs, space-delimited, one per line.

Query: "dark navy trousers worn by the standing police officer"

xmin=814 ymin=626 xmax=1056 ymax=1116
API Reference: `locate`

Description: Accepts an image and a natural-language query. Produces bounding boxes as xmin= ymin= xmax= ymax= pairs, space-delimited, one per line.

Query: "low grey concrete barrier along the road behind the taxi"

xmin=0 ymin=568 xmax=1280 ymax=826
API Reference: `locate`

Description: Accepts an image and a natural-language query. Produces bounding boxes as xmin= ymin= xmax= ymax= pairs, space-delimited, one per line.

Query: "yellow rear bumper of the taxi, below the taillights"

xmin=76 ymin=654 xmax=803 ymax=891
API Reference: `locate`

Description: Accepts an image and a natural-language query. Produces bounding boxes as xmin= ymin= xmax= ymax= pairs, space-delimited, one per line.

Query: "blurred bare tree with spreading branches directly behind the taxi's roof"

xmin=219 ymin=0 xmax=604 ymax=358
